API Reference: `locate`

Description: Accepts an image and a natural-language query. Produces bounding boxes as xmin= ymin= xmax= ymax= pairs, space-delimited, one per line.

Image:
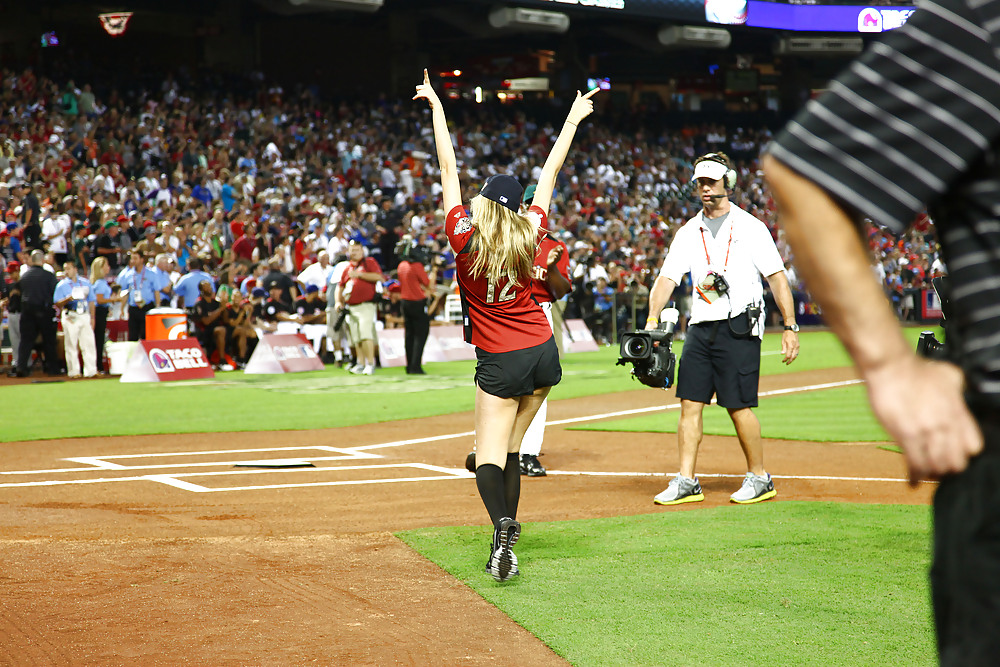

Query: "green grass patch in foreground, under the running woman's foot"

xmin=401 ymin=502 xmax=935 ymax=666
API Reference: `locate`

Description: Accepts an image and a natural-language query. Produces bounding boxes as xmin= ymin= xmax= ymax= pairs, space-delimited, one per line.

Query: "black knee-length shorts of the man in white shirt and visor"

xmin=677 ymin=314 xmax=760 ymax=409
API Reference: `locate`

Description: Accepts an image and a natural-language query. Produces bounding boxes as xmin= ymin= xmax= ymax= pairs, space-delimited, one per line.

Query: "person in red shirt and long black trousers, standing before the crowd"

xmin=396 ymin=236 xmax=441 ymax=375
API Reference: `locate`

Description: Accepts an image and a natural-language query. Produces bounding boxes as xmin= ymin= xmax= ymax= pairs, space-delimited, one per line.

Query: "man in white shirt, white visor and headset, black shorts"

xmin=646 ymin=153 xmax=799 ymax=505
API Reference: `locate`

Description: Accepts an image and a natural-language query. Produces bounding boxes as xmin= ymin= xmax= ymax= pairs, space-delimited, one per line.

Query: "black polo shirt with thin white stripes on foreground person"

xmin=768 ymin=0 xmax=1000 ymax=410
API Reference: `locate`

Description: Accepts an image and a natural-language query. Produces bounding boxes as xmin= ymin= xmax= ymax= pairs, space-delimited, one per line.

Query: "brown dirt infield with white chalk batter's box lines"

xmin=0 ymin=369 xmax=933 ymax=665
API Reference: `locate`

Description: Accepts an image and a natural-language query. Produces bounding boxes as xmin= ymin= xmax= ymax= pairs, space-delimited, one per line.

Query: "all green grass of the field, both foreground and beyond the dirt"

xmin=0 ymin=329 xmax=935 ymax=667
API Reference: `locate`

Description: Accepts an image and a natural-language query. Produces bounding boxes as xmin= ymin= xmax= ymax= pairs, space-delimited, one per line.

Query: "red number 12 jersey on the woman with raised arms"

xmin=444 ymin=206 xmax=552 ymax=352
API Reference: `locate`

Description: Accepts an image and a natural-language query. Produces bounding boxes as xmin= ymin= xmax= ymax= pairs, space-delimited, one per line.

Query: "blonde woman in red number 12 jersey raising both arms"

xmin=413 ymin=70 xmax=598 ymax=581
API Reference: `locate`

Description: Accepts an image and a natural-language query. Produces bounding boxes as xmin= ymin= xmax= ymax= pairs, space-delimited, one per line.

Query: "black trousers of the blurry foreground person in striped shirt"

xmin=931 ymin=417 xmax=1000 ymax=667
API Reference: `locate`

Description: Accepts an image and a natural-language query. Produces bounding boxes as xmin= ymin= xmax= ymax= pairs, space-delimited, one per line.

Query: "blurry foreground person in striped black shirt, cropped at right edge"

xmin=762 ymin=0 xmax=1000 ymax=656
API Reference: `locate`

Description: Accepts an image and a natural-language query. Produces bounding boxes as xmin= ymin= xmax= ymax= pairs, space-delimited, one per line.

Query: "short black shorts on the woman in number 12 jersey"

xmin=476 ymin=336 xmax=562 ymax=398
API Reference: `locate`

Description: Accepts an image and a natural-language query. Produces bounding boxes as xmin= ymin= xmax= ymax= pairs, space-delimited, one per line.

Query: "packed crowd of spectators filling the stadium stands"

xmin=0 ymin=68 xmax=943 ymax=380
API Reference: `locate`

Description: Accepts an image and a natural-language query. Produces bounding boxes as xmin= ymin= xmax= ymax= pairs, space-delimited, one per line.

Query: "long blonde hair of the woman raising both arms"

xmin=469 ymin=195 xmax=538 ymax=285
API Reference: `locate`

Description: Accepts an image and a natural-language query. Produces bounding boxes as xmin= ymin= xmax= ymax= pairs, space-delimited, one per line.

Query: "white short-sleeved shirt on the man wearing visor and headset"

xmin=660 ymin=204 xmax=785 ymax=335
